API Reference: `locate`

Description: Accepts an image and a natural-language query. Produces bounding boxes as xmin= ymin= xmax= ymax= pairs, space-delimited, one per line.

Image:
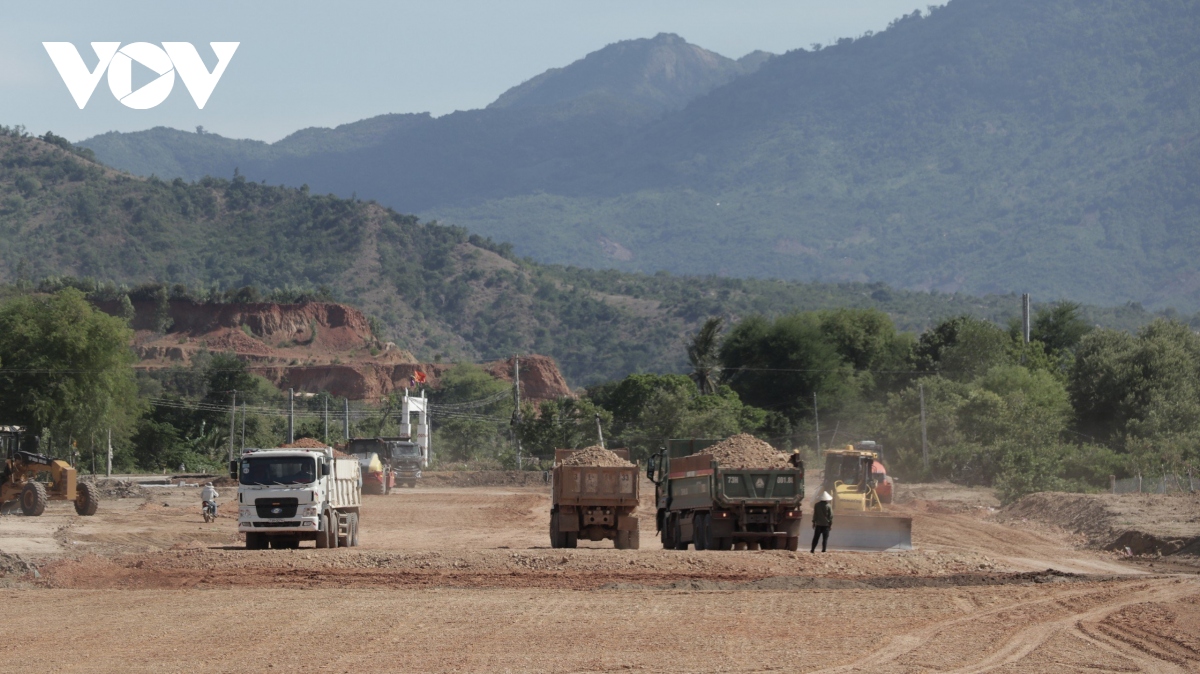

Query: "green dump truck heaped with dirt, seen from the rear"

xmin=647 ymin=440 xmax=804 ymax=550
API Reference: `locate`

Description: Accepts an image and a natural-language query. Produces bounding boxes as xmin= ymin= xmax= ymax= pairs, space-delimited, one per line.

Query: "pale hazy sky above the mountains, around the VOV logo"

xmin=0 ymin=0 xmax=928 ymax=140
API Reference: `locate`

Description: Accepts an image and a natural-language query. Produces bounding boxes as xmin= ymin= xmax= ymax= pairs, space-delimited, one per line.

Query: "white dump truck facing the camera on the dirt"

xmin=229 ymin=447 xmax=362 ymax=549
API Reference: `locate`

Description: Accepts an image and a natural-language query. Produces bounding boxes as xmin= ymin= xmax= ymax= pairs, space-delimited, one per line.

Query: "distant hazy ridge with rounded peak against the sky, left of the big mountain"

xmin=79 ymin=34 xmax=773 ymax=189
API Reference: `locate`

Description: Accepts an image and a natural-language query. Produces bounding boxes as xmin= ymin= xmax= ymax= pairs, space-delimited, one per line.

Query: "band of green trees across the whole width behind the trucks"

xmin=0 ymin=288 xmax=1200 ymax=500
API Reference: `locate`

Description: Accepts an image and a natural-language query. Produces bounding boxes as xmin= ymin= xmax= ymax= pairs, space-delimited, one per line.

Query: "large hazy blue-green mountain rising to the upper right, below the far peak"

xmin=79 ymin=0 xmax=1200 ymax=312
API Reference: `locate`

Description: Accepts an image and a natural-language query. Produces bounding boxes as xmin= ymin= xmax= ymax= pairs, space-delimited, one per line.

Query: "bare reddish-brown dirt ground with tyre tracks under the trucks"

xmin=0 ymin=474 xmax=1200 ymax=673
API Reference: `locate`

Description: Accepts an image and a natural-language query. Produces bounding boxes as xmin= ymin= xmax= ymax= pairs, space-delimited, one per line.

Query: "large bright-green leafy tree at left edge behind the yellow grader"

xmin=0 ymin=289 xmax=142 ymax=452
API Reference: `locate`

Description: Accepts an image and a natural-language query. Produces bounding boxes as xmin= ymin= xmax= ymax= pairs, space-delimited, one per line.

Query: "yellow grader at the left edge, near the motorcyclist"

xmin=0 ymin=426 xmax=100 ymax=517
